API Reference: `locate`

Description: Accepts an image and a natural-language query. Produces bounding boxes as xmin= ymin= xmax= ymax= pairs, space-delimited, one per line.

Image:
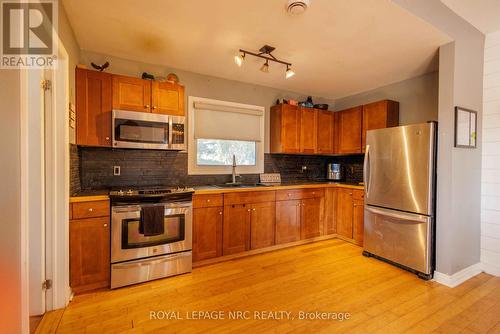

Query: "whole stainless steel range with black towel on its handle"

xmin=109 ymin=188 xmax=194 ymax=289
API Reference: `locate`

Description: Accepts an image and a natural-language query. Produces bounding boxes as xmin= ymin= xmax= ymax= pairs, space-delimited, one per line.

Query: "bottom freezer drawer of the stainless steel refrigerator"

xmin=364 ymin=205 xmax=433 ymax=275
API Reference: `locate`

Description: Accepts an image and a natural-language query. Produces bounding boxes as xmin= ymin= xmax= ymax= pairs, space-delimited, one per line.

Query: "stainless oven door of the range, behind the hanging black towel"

xmin=111 ymin=202 xmax=192 ymax=263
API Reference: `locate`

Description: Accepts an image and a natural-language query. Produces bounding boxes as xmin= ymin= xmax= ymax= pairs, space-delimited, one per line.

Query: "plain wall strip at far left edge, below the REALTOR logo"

xmin=0 ymin=70 xmax=21 ymax=333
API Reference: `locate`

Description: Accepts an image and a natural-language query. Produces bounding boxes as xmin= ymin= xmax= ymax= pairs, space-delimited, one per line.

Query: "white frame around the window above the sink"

xmin=187 ymin=96 xmax=265 ymax=175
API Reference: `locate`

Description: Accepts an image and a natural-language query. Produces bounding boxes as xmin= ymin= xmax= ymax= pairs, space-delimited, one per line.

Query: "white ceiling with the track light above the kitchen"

xmin=63 ymin=0 xmax=449 ymax=98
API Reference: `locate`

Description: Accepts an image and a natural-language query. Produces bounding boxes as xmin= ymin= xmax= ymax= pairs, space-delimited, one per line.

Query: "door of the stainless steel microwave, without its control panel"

xmin=113 ymin=110 xmax=170 ymax=149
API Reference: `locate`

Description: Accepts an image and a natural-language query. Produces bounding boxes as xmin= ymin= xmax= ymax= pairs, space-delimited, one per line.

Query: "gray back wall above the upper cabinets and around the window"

xmin=79 ymin=50 xmax=333 ymax=152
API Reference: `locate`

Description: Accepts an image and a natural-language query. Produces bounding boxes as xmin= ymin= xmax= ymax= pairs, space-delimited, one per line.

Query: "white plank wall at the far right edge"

xmin=481 ymin=31 xmax=500 ymax=276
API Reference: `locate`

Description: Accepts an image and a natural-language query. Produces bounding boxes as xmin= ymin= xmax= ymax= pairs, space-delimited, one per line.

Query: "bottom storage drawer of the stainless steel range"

xmin=111 ymin=251 xmax=192 ymax=289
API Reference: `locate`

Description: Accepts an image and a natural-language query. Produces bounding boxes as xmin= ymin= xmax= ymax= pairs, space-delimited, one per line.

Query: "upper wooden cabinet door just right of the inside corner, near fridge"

xmin=337 ymin=107 xmax=363 ymax=153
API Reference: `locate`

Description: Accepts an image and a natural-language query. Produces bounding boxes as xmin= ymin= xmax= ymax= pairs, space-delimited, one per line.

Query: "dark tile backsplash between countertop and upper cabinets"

xmin=70 ymin=145 xmax=363 ymax=194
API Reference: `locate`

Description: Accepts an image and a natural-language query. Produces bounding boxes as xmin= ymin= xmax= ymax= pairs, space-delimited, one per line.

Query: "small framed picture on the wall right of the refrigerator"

xmin=455 ymin=107 xmax=477 ymax=148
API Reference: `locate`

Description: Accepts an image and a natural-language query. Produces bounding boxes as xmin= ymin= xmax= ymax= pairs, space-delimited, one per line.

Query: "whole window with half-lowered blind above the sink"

xmin=188 ymin=96 xmax=264 ymax=174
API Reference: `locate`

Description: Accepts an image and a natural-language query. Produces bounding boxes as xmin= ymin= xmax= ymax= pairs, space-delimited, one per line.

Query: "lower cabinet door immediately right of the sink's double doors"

xmin=276 ymin=200 xmax=300 ymax=244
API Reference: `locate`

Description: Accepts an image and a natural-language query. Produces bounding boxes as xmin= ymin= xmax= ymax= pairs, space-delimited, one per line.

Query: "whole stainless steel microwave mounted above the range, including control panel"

xmin=113 ymin=110 xmax=186 ymax=150
